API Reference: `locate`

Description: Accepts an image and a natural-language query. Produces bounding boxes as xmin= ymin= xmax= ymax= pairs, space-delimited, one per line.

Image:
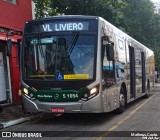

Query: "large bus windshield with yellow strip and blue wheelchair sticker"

xmin=23 ymin=31 xmax=96 ymax=81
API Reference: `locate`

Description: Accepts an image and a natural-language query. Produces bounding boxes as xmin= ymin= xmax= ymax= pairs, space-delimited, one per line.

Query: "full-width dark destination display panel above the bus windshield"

xmin=24 ymin=20 xmax=98 ymax=34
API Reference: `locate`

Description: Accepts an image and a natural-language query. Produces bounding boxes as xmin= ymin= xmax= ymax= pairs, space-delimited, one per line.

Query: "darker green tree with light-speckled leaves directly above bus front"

xmin=34 ymin=0 xmax=126 ymax=25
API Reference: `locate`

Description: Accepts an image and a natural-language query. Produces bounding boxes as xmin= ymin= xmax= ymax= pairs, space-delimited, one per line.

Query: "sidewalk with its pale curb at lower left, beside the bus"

xmin=0 ymin=105 xmax=40 ymax=129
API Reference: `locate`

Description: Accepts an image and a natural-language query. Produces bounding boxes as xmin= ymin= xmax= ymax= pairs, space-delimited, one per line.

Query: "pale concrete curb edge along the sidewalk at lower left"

xmin=0 ymin=114 xmax=42 ymax=129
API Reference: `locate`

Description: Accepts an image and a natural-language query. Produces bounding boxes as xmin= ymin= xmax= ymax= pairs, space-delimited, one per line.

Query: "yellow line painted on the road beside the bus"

xmin=96 ymin=94 xmax=156 ymax=140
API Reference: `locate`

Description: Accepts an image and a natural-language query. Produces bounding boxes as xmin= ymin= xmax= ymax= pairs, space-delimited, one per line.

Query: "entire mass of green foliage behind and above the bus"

xmin=33 ymin=0 xmax=160 ymax=68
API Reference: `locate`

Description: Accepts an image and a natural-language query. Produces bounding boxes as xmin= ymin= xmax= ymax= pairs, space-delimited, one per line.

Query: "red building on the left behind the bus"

xmin=0 ymin=0 xmax=33 ymax=104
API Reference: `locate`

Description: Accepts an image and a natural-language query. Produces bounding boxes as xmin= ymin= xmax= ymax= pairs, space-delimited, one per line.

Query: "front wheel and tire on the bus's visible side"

xmin=116 ymin=87 xmax=126 ymax=114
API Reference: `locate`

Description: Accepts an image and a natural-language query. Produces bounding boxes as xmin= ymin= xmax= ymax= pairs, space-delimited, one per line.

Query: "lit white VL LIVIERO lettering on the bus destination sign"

xmin=42 ymin=22 xmax=89 ymax=32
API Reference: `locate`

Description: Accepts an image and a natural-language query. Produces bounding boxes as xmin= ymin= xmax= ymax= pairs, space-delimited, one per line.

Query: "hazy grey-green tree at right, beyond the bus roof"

xmin=121 ymin=0 xmax=160 ymax=69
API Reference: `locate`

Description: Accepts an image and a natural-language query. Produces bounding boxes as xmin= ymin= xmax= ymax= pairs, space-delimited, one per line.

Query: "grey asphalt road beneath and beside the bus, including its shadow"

xmin=1 ymin=84 xmax=160 ymax=140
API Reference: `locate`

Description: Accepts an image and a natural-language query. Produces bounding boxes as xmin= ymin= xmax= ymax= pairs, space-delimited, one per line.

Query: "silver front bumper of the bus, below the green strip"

xmin=22 ymin=94 xmax=104 ymax=113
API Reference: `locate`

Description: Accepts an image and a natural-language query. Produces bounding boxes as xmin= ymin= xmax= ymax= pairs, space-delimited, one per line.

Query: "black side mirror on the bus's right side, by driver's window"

xmin=106 ymin=44 xmax=114 ymax=61
